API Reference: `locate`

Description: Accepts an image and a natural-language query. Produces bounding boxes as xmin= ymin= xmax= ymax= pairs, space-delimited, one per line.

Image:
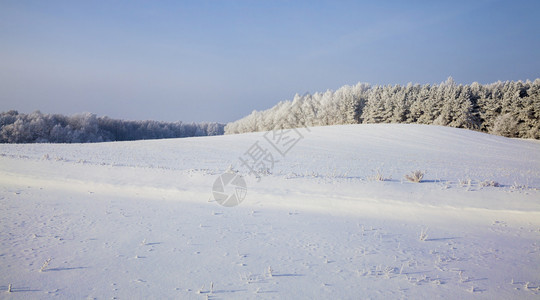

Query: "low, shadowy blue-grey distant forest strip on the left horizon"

xmin=0 ymin=110 xmax=225 ymax=143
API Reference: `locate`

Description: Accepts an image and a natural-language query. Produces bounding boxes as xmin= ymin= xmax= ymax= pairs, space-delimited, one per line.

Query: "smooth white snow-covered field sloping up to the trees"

xmin=0 ymin=124 xmax=540 ymax=299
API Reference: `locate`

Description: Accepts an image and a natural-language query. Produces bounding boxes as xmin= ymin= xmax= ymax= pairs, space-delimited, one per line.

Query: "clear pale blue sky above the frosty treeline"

xmin=0 ymin=0 xmax=540 ymax=123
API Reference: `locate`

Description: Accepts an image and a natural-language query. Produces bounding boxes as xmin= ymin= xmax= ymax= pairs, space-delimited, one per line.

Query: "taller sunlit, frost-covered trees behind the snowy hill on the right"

xmin=225 ymin=77 xmax=540 ymax=139
